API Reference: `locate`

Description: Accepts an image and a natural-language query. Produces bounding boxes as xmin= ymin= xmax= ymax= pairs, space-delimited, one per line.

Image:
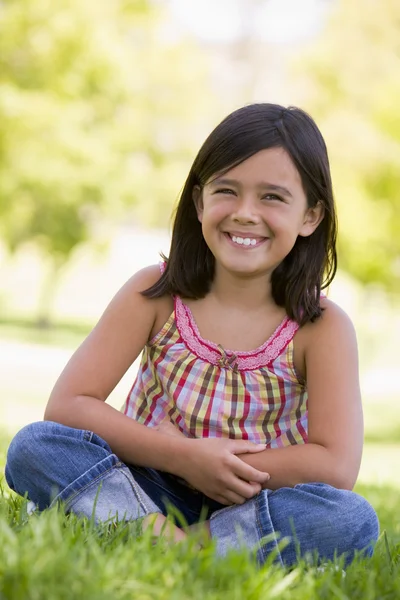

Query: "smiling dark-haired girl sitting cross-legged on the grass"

xmin=6 ymin=104 xmax=378 ymax=565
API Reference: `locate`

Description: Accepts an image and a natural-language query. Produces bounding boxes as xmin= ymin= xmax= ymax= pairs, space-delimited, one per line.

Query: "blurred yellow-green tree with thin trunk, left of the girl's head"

xmin=0 ymin=0 xmax=215 ymax=323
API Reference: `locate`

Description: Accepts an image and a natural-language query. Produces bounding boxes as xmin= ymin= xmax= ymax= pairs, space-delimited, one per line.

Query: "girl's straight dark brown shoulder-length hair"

xmin=142 ymin=103 xmax=337 ymax=325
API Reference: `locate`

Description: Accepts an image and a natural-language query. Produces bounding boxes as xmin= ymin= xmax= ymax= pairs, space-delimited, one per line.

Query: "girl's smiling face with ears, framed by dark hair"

xmin=193 ymin=148 xmax=323 ymax=276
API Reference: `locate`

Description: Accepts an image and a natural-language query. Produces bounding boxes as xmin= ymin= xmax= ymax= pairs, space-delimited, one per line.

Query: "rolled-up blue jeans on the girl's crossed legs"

xmin=6 ymin=421 xmax=379 ymax=566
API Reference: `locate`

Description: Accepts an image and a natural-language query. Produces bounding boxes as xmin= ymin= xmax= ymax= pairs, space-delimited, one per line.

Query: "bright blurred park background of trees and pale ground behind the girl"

xmin=0 ymin=0 xmax=400 ymax=488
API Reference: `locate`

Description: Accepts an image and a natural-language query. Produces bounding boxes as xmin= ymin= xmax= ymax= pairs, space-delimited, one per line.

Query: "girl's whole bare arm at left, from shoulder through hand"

xmin=44 ymin=266 xmax=267 ymax=504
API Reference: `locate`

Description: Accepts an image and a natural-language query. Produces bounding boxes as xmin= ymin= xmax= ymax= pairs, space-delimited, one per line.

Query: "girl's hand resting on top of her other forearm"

xmin=179 ymin=438 xmax=270 ymax=505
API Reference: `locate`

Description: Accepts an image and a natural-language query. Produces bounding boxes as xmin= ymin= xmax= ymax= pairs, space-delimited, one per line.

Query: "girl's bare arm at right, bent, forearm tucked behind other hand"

xmin=241 ymin=301 xmax=363 ymax=489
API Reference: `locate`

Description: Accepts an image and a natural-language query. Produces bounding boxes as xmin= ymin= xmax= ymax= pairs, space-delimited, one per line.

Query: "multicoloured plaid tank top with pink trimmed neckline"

xmin=123 ymin=288 xmax=308 ymax=448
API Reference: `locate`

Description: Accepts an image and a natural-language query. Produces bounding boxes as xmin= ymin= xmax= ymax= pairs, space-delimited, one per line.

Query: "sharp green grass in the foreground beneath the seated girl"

xmin=0 ymin=428 xmax=400 ymax=600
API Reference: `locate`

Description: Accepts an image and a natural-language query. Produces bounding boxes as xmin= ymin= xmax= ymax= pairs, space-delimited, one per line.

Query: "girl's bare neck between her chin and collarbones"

xmin=210 ymin=267 xmax=276 ymax=310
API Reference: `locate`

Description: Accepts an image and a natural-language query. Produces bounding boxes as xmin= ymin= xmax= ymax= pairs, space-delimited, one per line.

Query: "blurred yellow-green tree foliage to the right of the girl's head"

xmin=301 ymin=0 xmax=400 ymax=291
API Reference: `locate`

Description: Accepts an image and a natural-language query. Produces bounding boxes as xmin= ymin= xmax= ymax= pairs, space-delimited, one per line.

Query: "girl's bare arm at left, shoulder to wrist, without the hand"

xmin=44 ymin=266 xmax=191 ymax=471
